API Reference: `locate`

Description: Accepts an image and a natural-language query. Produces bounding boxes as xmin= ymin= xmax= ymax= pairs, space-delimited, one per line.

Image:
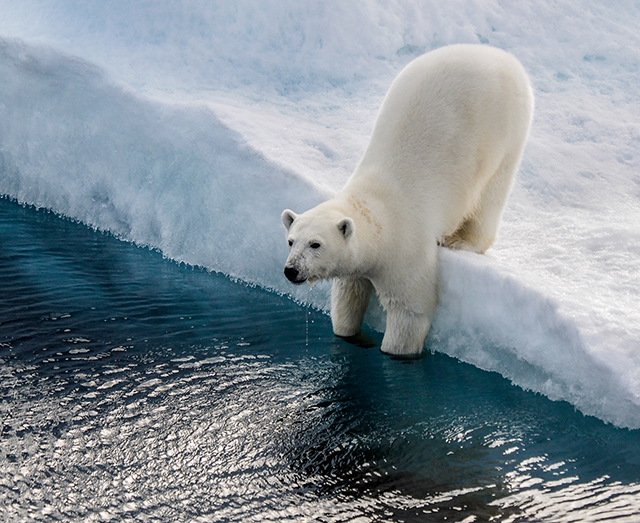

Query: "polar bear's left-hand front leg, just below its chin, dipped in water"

xmin=331 ymin=278 xmax=373 ymax=338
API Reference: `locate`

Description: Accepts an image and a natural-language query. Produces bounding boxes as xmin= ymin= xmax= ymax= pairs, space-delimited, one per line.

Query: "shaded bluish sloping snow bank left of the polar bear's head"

xmin=0 ymin=36 xmax=319 ymax=287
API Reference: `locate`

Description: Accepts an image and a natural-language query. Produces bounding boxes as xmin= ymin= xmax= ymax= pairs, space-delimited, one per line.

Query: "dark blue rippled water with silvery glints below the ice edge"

xmin=0 ymin=199 xmax=640 ymax=523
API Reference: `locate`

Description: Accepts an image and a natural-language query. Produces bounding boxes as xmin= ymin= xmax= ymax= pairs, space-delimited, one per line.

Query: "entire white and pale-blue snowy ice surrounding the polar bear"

xmin=0 ymin=0 xmax=640 ymax=428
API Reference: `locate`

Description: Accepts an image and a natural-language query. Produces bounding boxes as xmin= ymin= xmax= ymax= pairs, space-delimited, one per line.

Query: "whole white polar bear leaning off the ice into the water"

xmin=282 ymin=44 xmax=533 ymax=356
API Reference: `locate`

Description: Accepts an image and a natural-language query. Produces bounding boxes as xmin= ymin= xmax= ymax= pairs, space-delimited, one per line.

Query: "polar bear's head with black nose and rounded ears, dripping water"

xmin=282 ymin=205 xmax=355 ymax=285
